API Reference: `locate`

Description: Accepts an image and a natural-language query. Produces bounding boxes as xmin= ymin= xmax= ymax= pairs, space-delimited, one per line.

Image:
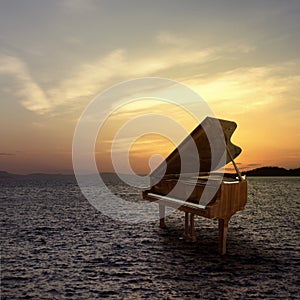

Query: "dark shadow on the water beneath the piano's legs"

xmin=157 ymin=216 xmax=286 ymax=276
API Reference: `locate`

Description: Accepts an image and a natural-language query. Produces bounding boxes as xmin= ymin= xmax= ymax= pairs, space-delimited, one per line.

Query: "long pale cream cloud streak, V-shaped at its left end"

xmin=0 ymin=49 xmax=218 ymax=114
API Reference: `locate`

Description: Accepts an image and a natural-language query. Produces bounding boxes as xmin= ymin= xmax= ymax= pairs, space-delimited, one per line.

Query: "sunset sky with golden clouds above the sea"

xmin=0 ymin=0 xmax=300 ymax=174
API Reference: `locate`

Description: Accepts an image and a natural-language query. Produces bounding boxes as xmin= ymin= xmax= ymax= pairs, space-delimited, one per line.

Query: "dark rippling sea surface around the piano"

xmin=0 ymin=176 xmax=300 ymax=300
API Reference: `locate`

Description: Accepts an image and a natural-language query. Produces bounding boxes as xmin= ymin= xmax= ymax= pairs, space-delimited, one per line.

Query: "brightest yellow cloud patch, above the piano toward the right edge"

xmin=185 ymin=61 xmax=300 ymax=114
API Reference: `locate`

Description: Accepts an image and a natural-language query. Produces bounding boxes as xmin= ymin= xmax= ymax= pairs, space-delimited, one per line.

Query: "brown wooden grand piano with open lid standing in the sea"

xmin=142 ymin=117 xmax=247 ymax=255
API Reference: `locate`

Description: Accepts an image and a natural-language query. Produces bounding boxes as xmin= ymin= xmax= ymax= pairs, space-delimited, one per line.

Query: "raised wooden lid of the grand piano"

xmin=151 ymin=117 xmax=242 ymax=177
